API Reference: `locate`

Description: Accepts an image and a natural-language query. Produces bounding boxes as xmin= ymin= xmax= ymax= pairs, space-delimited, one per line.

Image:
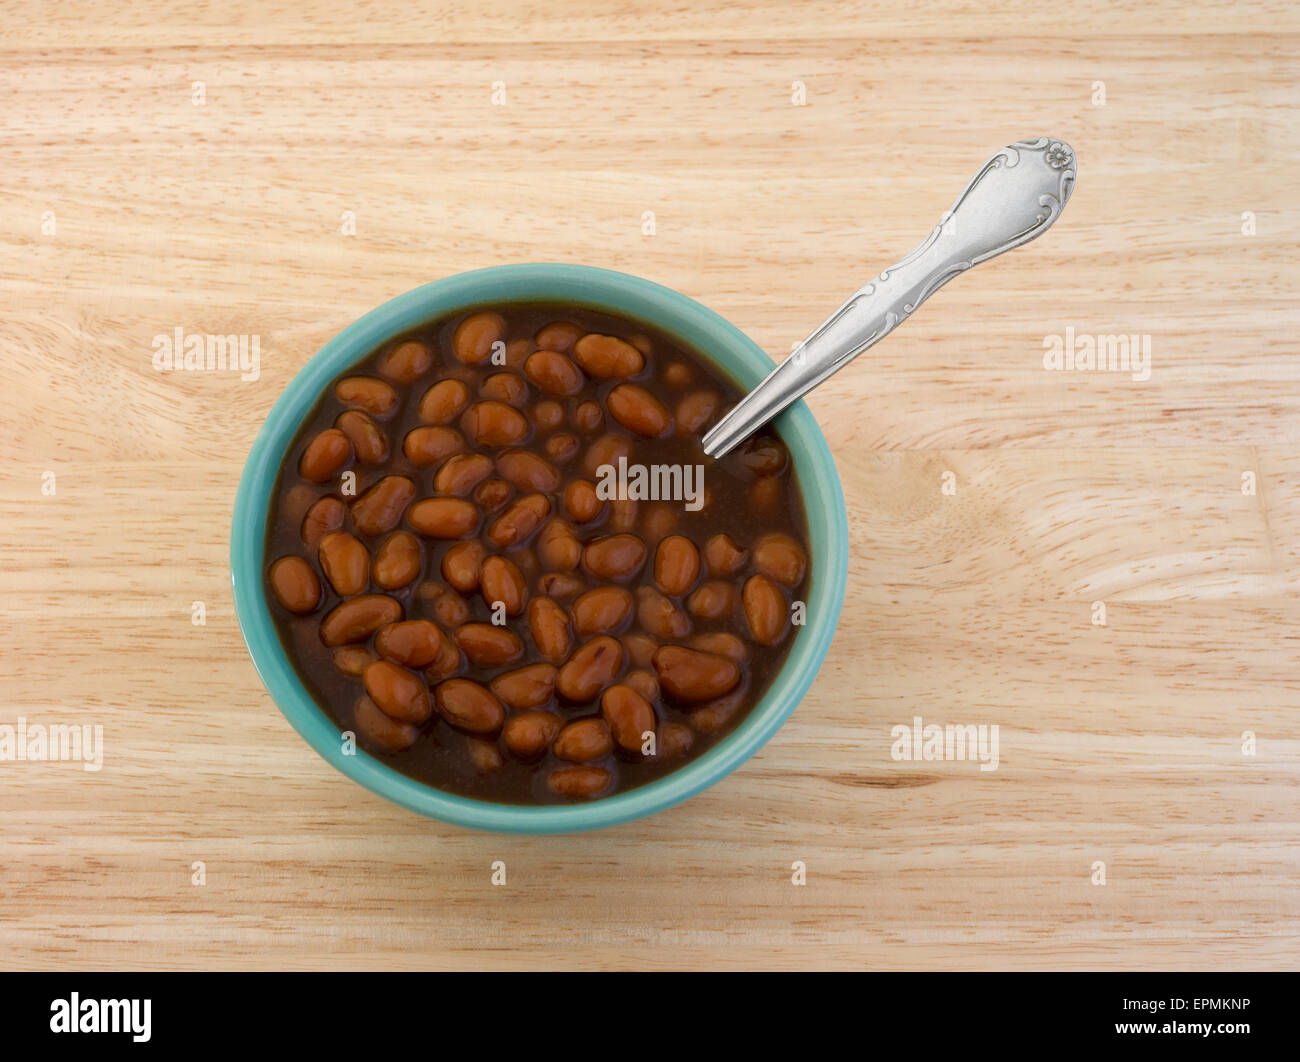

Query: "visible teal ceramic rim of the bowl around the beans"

xmin=230 ymin=264 xmax=849 ymax=833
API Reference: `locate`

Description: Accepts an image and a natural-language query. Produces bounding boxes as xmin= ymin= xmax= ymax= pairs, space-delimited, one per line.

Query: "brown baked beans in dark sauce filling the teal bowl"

xmin=265 ymin=305 xmax=810 ymax=803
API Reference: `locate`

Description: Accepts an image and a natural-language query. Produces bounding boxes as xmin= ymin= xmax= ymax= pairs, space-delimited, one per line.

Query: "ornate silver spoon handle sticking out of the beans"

xmin=703 ymin=136 xmax=1075 ymax=458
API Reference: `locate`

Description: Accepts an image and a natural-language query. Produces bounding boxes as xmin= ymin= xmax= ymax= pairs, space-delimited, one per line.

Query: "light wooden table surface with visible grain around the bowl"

xmin=0 ymin=0 xmax=1300 ymax=970
